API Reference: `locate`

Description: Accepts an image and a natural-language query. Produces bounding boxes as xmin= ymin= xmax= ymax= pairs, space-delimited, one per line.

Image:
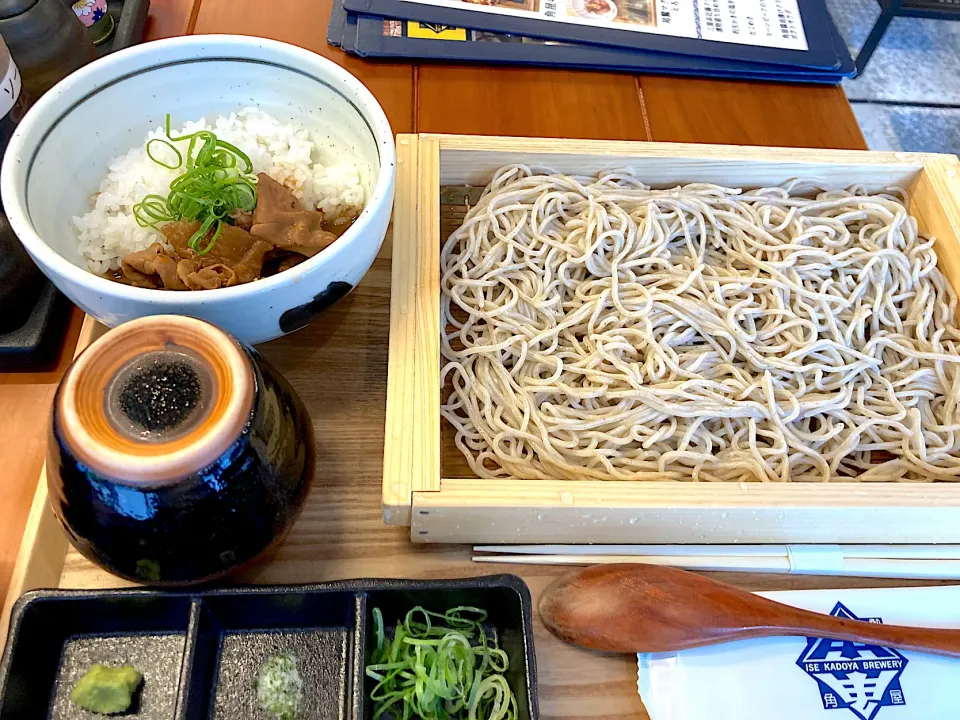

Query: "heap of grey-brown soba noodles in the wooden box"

xmin=441 ymin=165 xmax=960 ymax=481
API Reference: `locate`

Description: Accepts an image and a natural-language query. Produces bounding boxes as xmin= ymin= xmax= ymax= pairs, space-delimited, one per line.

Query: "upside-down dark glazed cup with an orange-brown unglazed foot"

xmin=47 ymin=315 xmax=315 ymax=585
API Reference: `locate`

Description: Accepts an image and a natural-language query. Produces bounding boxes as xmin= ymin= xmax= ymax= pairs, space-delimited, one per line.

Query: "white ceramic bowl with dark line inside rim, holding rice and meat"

xmin=0 ymin=35 xmax=396 ymax=344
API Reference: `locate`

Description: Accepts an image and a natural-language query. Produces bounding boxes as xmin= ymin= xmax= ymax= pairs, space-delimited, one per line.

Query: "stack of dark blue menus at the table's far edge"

xmin=327 ymin=0 xmax=855 ymax=84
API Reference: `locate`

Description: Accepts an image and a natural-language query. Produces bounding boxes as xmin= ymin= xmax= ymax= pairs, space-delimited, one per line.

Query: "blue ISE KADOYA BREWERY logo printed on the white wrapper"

xmin=797 ymin=603 xmax=908 ymax=720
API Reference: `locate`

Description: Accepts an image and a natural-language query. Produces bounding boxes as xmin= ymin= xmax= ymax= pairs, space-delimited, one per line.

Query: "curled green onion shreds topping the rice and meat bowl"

xmin=133 ymin=115 xmax=257 ymax=255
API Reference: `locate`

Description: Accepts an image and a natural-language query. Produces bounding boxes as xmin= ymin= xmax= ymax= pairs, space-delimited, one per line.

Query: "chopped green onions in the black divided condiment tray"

xmin=366 ymin=606 xmax=517 ymax=720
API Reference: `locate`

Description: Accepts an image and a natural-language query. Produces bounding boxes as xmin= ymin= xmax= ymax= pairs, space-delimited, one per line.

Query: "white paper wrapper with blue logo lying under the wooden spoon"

xmin=637 ymin=586 xmax=960 ymax=720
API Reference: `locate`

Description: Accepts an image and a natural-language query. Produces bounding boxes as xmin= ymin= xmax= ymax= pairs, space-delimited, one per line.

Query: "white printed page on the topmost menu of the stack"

xmin=394 ymin=0 xmax=808 ymax=50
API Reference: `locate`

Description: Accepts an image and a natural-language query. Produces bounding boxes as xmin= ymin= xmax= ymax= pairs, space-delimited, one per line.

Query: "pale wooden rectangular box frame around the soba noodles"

xmin=382 ymin=134 xmax=960 ymax=543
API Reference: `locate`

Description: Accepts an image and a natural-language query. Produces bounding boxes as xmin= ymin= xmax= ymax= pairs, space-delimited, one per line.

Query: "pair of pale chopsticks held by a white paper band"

xmin=473 ymin=545 xmax=960 ymax=580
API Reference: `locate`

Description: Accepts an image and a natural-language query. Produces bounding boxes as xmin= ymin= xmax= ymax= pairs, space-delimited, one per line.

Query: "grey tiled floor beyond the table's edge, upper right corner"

xmin=827 ymin=0 xmax=960 ymax=153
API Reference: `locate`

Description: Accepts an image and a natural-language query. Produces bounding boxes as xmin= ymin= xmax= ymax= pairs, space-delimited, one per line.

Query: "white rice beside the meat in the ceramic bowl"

xmin=73 ymin=107 xmax=366 ymax=273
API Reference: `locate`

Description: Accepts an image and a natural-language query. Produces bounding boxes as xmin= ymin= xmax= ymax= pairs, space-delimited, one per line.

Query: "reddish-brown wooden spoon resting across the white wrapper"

xmin=540 ymin=563 xmax=960 ymax=657
